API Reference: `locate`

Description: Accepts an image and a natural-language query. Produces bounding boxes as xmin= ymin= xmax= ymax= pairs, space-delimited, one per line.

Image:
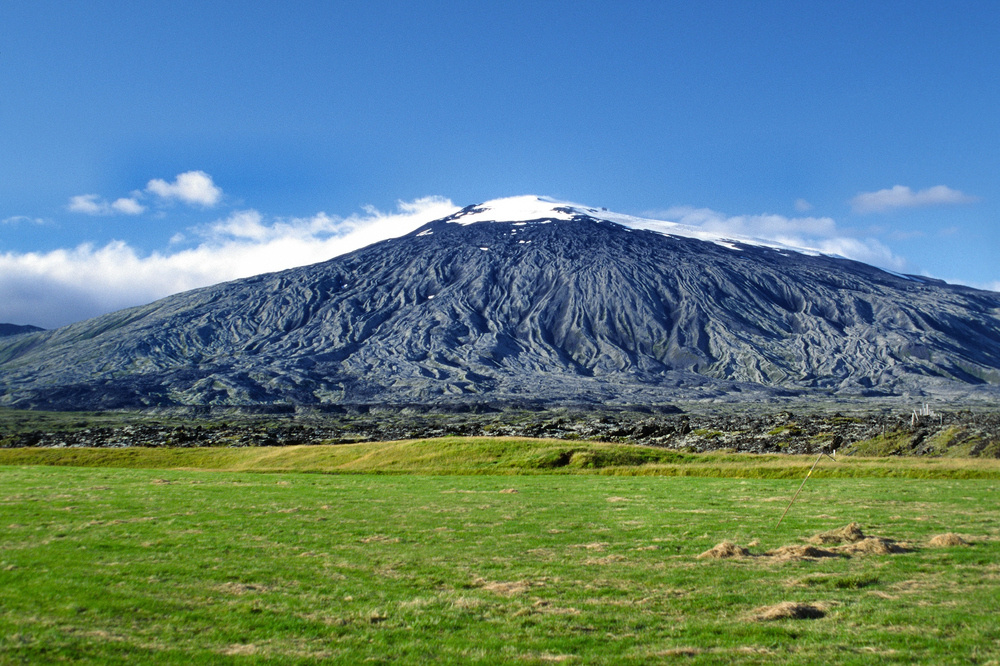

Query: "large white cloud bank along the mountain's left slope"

xmin=0 ymin=197 xmax=458 ymax=328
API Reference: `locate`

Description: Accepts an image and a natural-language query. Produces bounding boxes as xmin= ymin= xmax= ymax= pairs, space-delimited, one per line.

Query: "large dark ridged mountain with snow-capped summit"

xmin=0 ymin=197 xmax=1000 ymax=409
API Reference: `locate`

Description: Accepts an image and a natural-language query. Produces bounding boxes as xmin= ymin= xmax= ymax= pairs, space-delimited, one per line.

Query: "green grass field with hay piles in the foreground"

xmin=0 ymin=439 xmax=1000 ymax=664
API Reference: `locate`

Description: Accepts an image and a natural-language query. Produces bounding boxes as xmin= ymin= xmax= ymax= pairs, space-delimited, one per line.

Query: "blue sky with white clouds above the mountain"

xmin=0 ymin=0 xmax=1000 ymax=327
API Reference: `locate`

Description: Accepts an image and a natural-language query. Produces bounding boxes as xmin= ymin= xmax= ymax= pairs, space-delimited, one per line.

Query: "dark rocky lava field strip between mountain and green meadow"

xmin=0 ymin=407 xmax=1000 ymax=458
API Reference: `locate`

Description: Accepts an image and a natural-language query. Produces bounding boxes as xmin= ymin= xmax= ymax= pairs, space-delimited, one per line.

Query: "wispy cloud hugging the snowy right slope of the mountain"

xmin=648 ymin=206 xmax=908 ymax=271
